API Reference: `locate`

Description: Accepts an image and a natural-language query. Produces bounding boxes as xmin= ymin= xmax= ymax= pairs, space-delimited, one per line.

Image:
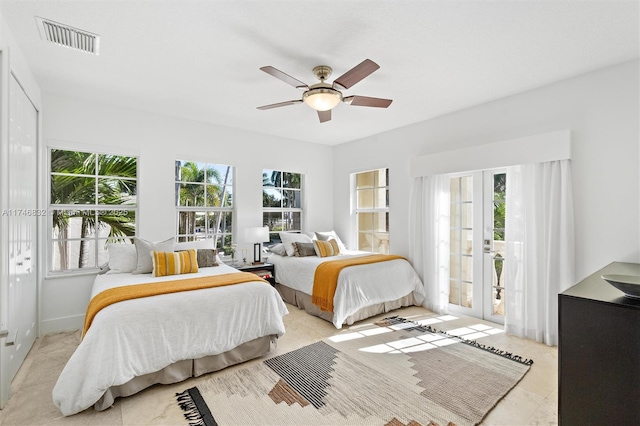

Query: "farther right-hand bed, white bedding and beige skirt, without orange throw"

xmin=269 ymin=250 xmax=425 ymax=329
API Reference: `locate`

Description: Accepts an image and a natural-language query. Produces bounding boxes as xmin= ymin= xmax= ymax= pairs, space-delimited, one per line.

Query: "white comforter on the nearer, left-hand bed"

xmin=53 ymin=264 xmax=288 ymax=416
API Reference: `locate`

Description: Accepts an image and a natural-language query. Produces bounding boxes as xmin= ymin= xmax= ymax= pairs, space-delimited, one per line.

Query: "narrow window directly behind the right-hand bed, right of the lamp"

xmin=262 ymin=170 xmax=303 ymax=242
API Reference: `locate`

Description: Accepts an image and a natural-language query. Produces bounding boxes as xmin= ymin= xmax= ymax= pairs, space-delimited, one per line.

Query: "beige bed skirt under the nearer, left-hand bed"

xmin=93 ymin=335 xmax=278 ymax=411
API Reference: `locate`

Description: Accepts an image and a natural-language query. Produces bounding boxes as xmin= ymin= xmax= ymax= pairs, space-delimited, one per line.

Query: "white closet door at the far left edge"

xmin=0 ymin=75 xmax=38 ymax=398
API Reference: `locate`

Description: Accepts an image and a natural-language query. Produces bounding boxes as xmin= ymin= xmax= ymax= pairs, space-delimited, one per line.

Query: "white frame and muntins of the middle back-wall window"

xmin=173 ymin=160 xmax=236 ymax=250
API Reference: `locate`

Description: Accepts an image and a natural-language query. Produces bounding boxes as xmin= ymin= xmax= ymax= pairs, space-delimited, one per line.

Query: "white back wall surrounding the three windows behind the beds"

xmin=40 ymin=93 xmax=333 ymax=333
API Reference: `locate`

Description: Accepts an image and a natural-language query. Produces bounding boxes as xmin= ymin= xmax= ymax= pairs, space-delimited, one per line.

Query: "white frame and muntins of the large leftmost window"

xmin=49 ymin=144 xmax=140 ymax=277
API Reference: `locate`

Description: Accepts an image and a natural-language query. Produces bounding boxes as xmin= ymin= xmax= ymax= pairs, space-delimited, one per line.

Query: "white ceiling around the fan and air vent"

xmin=0 ymin=0 xmax=639 ymax=145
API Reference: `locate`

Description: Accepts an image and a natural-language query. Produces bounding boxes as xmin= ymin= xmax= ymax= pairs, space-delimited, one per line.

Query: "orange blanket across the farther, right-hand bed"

xmin=311 ymin=254 xmax=406 ymax=312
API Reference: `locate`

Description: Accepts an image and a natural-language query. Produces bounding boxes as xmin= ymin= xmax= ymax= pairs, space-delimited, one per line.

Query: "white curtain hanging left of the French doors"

xmin=409 ymin=175 xmax=449 ymax=314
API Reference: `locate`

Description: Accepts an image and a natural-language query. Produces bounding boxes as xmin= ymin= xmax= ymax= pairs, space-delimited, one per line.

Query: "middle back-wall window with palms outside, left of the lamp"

xmin=175 ymin=160 xmax=234 ymax=251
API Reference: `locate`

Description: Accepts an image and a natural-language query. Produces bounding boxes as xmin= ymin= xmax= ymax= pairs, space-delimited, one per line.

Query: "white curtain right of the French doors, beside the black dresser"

xmin=504 ymin=160 xmax=575 ymax=346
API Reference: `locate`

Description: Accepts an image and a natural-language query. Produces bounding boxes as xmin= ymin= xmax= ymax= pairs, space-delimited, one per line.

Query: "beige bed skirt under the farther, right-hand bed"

xmin=275 ymin=283 xmax=416 ymax=325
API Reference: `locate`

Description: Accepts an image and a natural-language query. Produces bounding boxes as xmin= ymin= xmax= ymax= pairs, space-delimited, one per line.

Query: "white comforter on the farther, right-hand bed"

xmin=269 ymin=251 xmax=425 ymax=329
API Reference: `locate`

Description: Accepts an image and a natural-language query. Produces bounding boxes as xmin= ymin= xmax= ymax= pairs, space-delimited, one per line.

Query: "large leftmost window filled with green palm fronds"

xmin=49 ymin=149 xmax=138 ymax=271
